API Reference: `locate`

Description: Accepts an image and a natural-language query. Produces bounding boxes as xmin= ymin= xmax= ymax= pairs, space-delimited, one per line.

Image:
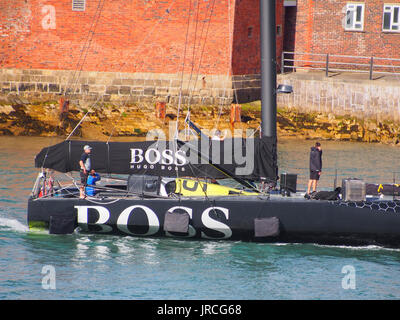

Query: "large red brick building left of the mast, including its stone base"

xmin=0 ymin=0 xmax=284 ymax=105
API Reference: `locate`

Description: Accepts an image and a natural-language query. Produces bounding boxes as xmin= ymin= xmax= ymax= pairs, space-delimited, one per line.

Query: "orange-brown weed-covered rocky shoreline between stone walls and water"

xmin=0 ymin=101 xmax=400 ymax=145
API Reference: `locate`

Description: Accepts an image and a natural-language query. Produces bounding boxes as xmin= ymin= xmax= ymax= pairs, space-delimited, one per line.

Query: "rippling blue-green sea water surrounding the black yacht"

xmin=0 ymin=137 xmax=400 ymax=300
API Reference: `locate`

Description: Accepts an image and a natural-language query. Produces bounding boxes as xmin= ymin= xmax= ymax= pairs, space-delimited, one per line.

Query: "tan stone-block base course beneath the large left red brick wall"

xmin=0 ymin=69 xmax=261 ymax=105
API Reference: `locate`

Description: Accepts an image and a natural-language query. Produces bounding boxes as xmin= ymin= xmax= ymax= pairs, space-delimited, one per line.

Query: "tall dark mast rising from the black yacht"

xmin=260 ymin=0 xmax=276 ymax=138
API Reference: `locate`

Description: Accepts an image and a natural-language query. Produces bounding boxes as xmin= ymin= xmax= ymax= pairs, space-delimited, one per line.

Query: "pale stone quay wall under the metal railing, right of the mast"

xmin=278 ymin=73 xmax=400 ymax=122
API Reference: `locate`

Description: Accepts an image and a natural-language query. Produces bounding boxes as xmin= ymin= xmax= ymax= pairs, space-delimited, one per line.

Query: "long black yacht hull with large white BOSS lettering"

xmin=28 ymin=197 xmax=400 ymax=247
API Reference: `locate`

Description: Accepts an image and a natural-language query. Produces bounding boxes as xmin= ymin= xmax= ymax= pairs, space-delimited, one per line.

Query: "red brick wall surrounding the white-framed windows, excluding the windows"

xmin=295 ymin=0 xmax=400 ymax=68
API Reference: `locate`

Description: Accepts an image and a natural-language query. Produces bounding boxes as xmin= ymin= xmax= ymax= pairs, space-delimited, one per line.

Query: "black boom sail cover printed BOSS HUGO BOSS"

xmin=35 ymin=137 xmax=278 ymax=181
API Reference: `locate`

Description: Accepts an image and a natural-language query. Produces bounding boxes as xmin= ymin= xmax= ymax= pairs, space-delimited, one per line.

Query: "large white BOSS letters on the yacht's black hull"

xmin=75 ymin=205 xmax=232 ymax=239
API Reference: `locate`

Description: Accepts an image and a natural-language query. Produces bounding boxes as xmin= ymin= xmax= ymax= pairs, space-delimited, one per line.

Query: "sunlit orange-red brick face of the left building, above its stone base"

xmin=0 ymin=0 xmax=234 ymax=74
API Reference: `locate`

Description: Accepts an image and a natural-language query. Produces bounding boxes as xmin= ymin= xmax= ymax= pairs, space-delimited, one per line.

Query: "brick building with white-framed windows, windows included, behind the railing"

xmin=285 ymin=0 xmax=400 ymax=72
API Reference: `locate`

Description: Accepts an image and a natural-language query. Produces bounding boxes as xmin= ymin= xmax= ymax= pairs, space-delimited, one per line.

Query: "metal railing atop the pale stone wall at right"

xmin=281 ymin=51 xmax=400 ymax=80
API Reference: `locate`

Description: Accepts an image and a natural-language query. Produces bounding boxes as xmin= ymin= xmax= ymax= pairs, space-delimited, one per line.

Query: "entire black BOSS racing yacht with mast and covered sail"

xmin=27 ymin=0 xmax=400 ymax=247
